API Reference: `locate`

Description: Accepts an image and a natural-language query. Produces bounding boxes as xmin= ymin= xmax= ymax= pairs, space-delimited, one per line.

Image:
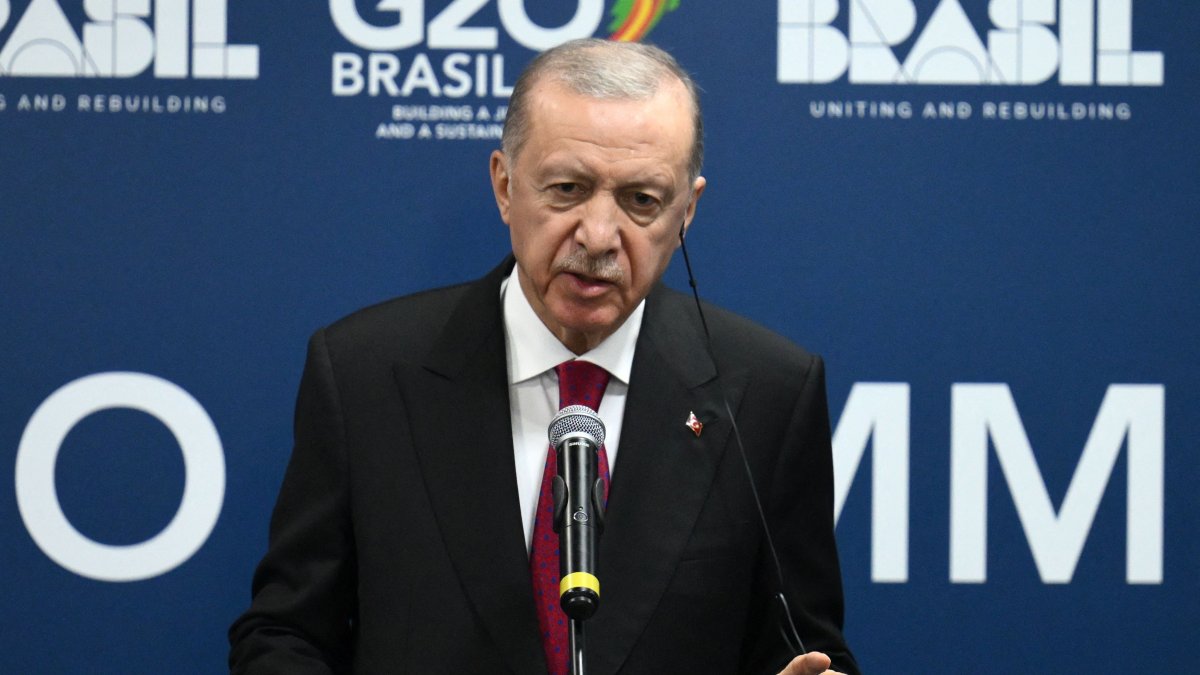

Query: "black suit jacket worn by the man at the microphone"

xmin=230 ymin=258 xmax=857 ymax=675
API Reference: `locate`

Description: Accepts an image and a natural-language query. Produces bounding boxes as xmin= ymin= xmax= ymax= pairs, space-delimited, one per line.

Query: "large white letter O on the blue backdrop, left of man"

xmin=16 ymin=372 xmax=226 ymax=581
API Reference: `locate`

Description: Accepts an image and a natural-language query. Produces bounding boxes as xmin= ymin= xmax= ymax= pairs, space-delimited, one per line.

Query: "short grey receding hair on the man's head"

xmin=500 ymin=37 xmax=704 ymax=180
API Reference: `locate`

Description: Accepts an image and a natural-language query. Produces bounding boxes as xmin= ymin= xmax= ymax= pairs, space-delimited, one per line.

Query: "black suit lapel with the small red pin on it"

xmin=588 ymin=284 xmax=738 ymax=675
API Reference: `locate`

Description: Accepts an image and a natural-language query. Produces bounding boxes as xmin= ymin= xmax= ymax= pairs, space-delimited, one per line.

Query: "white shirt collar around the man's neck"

xmin=500 ymin=268 xmax=646 ymax=384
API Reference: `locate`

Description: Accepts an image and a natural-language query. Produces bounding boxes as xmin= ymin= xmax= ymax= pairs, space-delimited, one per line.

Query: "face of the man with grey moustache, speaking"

xmin=491 ymin=80 xmax=704 ymax=353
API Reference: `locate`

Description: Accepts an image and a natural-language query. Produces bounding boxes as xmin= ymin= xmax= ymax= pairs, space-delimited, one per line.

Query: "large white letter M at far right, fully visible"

xmin=950 ymin=384 xmax=1165 ymax=584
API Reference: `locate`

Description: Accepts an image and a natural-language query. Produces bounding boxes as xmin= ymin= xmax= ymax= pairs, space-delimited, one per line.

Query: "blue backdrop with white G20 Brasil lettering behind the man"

xmin=0 ymin=0 xmax=1200 ymax=674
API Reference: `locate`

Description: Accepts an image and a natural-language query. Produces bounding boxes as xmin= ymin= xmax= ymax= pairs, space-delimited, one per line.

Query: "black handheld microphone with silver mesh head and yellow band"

xmin=548 ymin=406 xmax=605 ymax=621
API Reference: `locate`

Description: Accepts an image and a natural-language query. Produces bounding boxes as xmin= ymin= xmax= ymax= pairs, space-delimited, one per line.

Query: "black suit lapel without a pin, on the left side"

xmin=396 ymin=258 xmax=545 ymax=673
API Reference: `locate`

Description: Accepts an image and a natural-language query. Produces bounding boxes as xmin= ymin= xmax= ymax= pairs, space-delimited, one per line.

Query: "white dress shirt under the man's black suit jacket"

xmin=500 ymin=268 xmax=646 ymax=550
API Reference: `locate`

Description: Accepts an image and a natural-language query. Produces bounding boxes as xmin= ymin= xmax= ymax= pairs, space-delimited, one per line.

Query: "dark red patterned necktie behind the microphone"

xmin=529 ymin=360 xmax=608 ymax=675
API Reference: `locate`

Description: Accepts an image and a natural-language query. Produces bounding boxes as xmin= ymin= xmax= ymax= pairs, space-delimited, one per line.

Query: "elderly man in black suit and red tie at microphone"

xmin=230 ymin=40 xmax=857 ymax=675
